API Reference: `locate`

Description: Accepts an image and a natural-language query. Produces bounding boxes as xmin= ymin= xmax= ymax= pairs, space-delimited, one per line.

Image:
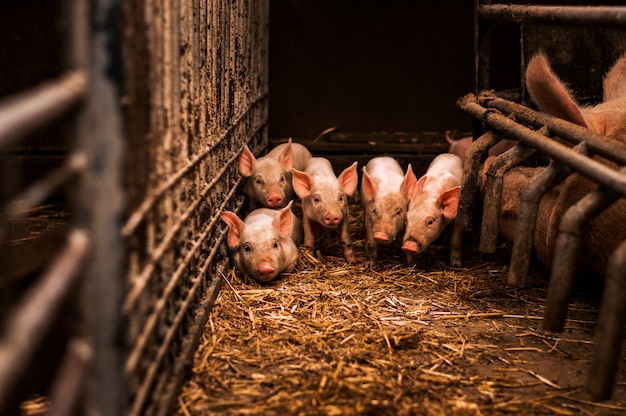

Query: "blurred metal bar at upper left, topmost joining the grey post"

xmin=0 ymin=70 xmax=87 ymax=150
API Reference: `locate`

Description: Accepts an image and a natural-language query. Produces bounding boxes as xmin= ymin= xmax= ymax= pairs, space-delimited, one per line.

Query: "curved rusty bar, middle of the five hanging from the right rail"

xmin=507 ymin=159 xmax=571 ymax=287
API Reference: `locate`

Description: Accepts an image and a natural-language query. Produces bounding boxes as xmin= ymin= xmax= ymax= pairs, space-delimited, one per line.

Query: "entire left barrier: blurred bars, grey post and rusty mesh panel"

xmin=0 ymin=0 xmax=269 ymax=415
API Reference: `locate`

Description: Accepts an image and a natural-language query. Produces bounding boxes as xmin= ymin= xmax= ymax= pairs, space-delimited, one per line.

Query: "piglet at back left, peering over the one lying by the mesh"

xmin=239 ymin=139 xmax=311 ymax=209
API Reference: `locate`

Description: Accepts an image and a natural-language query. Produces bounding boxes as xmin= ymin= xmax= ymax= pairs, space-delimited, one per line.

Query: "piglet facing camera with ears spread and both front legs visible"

xmin=292 ymin=157 xmax=358 ymax=263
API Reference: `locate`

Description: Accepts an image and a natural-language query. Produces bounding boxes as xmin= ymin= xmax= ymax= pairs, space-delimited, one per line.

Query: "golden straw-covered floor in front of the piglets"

xmin=176 ymin=197 xmax=626 ymax=415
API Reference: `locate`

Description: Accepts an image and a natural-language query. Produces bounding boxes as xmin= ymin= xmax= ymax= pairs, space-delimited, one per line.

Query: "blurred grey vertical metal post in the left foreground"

xmin=80 ymin=0 xmax=126 ymax=416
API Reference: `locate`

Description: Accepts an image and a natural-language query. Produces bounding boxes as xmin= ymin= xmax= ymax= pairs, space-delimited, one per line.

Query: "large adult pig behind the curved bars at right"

xmin=485 ymin=54 xmax=626 ymax=275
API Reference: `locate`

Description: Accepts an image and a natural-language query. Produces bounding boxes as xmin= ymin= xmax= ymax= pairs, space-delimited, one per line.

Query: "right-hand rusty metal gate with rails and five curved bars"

xmin=457 ymin=2 xmax=626 ymax=399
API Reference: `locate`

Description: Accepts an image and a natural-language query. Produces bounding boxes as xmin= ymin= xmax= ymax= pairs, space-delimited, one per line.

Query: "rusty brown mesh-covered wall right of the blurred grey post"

xmin=122 ymin=0 xmax=269 ymax=414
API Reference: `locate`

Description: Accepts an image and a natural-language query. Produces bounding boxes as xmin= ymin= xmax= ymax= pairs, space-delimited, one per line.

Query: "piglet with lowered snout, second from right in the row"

xmin=361 ymin=156 xmax=417 ymax=265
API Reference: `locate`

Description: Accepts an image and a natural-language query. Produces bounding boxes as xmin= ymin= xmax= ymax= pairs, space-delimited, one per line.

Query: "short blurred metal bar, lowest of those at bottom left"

xmin=46 ymin=339 xmax=93 ymax=416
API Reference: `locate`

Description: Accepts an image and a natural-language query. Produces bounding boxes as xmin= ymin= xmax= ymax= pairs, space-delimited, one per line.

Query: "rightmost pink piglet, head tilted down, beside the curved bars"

xmin=402 ymin=153 xmax=463 ymax=266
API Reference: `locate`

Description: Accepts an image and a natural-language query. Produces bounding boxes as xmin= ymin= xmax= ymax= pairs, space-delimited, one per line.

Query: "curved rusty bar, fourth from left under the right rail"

xmin=543 ymin=169 xmax=626 ymax=332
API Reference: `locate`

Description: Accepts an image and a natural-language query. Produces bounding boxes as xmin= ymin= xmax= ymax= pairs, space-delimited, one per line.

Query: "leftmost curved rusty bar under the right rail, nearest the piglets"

xmin=455 ymin=130 xmax=500 ymax=228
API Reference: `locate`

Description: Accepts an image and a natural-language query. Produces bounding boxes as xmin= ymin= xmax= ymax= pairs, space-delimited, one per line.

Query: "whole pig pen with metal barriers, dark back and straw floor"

xmin=0 ymin=0 xmax=626 ymax=415
